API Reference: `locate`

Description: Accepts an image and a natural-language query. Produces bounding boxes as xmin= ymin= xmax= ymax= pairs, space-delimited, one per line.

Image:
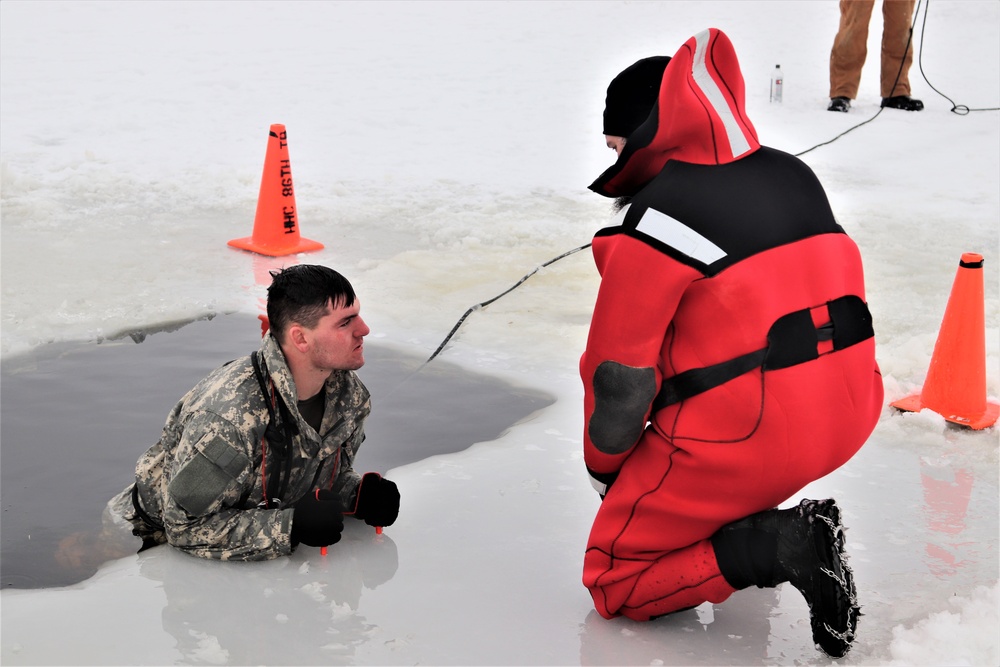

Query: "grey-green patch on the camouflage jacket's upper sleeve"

xmin=167 ymin=437 xmax=250 ymax=516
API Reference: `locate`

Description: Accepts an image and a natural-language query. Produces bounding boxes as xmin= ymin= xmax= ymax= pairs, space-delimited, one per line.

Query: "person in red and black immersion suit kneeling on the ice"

xmin=580 ymin=28 xmax=883 ymax=657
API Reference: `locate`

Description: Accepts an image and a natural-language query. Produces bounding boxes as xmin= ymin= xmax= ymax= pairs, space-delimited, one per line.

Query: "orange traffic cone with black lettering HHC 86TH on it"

xmin=229 ymin=124 xmax=323 ymax=257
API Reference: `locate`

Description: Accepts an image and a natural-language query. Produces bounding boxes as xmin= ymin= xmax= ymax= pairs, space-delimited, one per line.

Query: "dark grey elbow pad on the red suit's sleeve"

xmin=587 ymin=361 xmax=656 ymax=454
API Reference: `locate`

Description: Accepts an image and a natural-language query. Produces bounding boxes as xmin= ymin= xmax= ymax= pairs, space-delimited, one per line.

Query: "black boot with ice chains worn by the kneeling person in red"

xmin=712 ymin=499 xmax=861 ymax=658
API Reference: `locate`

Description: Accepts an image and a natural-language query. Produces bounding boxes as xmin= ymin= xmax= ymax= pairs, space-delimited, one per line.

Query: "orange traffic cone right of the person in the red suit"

xmin=891 ymin=252 xmax=1000 ymax=430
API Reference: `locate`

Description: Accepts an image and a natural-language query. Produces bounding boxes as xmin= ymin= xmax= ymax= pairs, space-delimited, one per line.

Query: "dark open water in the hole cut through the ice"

xmin=0 ymin=315 xmax=554 ymax=588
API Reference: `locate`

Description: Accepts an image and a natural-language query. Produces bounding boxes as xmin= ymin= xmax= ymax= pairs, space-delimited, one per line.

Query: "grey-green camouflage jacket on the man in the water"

xmin=111 ymin=334 xmax=371 ymax=560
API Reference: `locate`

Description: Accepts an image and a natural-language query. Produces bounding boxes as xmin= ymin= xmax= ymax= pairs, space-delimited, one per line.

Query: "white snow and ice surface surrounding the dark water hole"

xmin=0 ymin=0 xmax=1000 ymax=665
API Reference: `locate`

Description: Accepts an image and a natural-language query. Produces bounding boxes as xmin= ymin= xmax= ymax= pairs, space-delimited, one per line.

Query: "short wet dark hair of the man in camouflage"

xmin=267 ymin=264 xmax=355 ymax=340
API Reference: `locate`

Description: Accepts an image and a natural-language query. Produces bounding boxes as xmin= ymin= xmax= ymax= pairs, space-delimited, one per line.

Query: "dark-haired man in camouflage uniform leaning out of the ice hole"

xmin=112 ymin=265 xmax=399 ymax=560
